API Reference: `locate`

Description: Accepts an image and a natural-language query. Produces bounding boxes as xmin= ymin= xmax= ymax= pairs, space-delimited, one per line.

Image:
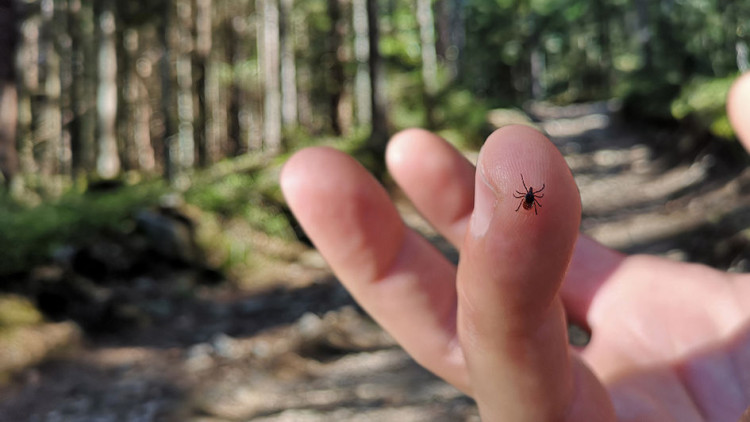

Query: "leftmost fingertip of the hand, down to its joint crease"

xmin=281 ymin=147 xmax=405 ymax=286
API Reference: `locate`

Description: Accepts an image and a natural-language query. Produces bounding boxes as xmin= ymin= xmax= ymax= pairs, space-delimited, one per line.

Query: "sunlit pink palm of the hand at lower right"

xmin=581 ymin=256 xmax=750 ymax=421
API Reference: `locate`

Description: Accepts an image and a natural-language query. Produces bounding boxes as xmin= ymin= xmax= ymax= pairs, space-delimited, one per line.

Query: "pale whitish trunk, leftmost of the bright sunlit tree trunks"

xmin=96 ymin=0 xmax=120 ymax=178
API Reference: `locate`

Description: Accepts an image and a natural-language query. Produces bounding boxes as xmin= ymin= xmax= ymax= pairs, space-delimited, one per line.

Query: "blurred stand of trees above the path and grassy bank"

xmin=0 ymin=0 xmax=750 ymax=193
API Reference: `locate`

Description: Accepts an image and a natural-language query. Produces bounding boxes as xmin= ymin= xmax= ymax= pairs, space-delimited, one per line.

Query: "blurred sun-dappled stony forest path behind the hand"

xmin=0 ymin=103 xmax=750 ymax=422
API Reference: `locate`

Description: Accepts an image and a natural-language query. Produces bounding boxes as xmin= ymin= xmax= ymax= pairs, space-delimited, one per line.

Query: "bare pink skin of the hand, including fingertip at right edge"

xmin=281 ymin=75 xmax=750 ymax=422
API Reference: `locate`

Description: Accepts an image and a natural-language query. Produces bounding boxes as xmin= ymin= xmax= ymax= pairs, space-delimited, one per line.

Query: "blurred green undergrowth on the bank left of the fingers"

xmin=0 ymin=152 xmax=302 ymax=277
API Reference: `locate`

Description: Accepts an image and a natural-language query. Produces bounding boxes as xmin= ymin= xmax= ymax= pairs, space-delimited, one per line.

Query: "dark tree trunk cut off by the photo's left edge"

xmin=0 ymin=0 xmax=18 ymax=187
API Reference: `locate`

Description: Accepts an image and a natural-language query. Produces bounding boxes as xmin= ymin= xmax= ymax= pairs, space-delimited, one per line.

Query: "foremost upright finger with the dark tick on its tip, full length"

xmin=457 ymin=126 xmax=612 ymax=421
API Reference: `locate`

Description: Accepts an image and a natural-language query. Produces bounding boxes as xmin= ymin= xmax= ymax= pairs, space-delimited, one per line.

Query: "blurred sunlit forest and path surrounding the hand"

xmin=0 ymin=0 xmax=750 ymax=422
